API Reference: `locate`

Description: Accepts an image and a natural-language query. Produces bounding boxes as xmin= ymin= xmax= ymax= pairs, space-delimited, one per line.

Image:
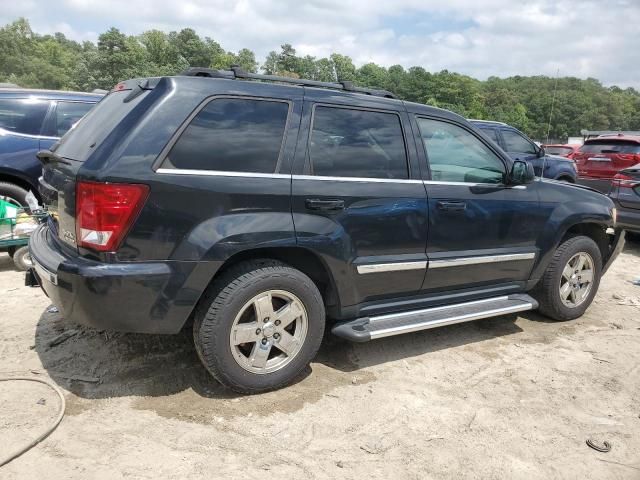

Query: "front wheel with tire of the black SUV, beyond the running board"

xmin=532 ymin=235 xmax=602 ymax=320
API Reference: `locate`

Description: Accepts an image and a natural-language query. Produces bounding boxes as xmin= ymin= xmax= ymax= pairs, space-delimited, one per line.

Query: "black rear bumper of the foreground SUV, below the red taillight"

xmin=29 ymin=225 xmax=202 ymax=333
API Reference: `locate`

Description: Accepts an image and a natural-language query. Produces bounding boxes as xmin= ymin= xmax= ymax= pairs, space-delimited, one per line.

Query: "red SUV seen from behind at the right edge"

xmin=573 ymin=134 xmax=640 ymax=193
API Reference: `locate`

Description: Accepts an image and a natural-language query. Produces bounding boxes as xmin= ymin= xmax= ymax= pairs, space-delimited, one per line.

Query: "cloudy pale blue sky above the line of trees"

xmin=0 ymin=0 xmax=640 ymax=88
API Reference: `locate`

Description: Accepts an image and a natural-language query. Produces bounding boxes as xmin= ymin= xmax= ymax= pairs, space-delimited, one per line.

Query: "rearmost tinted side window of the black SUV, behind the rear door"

xmin=163 ymin=98 xmax=289 ymax=173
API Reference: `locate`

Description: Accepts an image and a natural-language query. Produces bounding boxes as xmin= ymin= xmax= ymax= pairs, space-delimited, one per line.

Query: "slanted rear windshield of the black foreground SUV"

xmin=55 ymin=90 xmax=148 ymax=162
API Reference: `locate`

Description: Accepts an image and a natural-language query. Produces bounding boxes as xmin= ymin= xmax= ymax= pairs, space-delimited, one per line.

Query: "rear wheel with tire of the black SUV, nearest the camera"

xmin=193 ymin=260 xmax=325 ymax=393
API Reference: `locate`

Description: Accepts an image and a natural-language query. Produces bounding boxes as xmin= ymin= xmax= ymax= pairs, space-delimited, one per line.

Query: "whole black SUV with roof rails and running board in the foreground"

xmin=27 ymin=69 xmax=624 ymax=393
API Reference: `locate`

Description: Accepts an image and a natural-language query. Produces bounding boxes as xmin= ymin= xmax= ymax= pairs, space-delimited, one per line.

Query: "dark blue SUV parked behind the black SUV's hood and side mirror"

xmin=469 ymin=120 xmax=578 ymax=183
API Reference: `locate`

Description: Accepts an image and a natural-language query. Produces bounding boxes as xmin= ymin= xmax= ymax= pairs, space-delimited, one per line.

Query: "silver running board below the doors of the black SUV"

xmin=331 ymin=293 xmax=538 ymax=342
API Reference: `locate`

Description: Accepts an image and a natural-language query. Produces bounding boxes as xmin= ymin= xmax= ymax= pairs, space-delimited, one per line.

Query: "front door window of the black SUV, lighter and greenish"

xmin=418 ymin=118 xmax=505 ymax=183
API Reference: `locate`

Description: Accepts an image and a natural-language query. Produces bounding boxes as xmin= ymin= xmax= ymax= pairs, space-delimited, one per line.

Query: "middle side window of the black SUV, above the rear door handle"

xmin=309 ymin=106 xmax=408 ymax=179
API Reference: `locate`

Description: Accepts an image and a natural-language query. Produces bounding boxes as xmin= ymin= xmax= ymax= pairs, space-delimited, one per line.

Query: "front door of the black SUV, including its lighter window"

xmin=416 ymin=117 xmax=546 ymax=292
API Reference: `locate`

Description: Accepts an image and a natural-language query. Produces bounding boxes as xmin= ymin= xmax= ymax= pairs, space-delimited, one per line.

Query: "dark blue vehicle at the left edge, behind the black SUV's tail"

xmin=0 ymin=88 xmax=103 ymax=206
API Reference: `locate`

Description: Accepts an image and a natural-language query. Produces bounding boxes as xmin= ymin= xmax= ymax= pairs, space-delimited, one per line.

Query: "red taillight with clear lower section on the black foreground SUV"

xmin=76 ymin=182 xmax=149 ymax=252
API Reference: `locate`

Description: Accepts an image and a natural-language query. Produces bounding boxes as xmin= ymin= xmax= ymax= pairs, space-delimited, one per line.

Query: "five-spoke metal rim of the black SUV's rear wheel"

xmin=229 ymin=290 xmax=309 ymax=374
